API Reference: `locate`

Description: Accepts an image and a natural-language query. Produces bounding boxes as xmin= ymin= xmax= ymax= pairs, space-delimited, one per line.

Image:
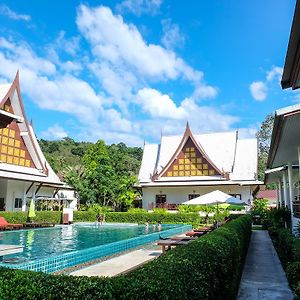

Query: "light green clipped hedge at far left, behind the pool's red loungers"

xmin=0 ymin=211 xmax=61 ymax=224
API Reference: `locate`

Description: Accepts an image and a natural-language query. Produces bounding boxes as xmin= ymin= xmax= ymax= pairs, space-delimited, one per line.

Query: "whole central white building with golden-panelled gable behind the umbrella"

xmin=139 ymin=124 xmax=262 ymax=210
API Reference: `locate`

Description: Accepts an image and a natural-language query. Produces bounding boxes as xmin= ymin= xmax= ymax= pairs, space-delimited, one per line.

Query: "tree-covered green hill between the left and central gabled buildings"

xmin=39 ymin=138 xmax=143 ymax=210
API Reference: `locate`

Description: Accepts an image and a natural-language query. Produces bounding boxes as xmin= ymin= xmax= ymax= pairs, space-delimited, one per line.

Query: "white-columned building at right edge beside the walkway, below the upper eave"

xmin=265 ymin=104 xmax=300 ymax=231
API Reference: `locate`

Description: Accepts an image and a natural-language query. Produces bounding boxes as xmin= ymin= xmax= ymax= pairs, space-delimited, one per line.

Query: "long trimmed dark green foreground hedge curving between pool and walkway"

xmin=0 ymin=216 xmax=251 ymax=300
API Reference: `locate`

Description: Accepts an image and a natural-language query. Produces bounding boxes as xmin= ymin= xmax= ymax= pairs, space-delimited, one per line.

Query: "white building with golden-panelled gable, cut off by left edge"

xmin=0 ymin=73 xmax=74 ymax=211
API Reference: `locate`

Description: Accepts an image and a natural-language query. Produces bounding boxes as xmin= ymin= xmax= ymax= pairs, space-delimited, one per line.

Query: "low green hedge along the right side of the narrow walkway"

xmin=269 ymin=228 xmax=300 ymax=299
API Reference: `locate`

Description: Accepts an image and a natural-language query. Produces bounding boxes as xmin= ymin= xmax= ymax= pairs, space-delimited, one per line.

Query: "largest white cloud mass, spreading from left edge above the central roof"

xmin=0 ymin=5 xmax=238 ymax=145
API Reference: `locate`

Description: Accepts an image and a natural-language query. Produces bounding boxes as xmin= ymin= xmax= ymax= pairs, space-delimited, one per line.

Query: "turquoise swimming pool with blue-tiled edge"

xmin=0 ymin=223 xmax=191 ymax=273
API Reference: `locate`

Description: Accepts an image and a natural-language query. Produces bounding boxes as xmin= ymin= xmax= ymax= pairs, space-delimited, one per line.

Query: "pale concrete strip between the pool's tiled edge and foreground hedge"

xmin=70 ymin=249 xmax=161 ymax=277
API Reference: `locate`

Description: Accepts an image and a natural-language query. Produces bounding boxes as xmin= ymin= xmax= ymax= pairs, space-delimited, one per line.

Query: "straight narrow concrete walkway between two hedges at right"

xmin=237 ymin=230 xmax=294 ymax=300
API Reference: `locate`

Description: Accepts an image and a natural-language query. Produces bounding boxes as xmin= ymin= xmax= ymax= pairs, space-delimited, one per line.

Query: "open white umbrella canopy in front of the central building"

xmin=182 ymin=190 xmax=245 ymax=205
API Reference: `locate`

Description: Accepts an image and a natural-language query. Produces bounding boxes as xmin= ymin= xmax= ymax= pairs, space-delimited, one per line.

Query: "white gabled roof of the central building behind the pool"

xmin=139 ymin=125 xmax=257 ymax=184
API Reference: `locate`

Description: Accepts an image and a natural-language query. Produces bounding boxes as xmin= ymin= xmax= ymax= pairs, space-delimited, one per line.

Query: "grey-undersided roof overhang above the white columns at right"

xmin=267 ymin=104 xmax=300 ymax=169
